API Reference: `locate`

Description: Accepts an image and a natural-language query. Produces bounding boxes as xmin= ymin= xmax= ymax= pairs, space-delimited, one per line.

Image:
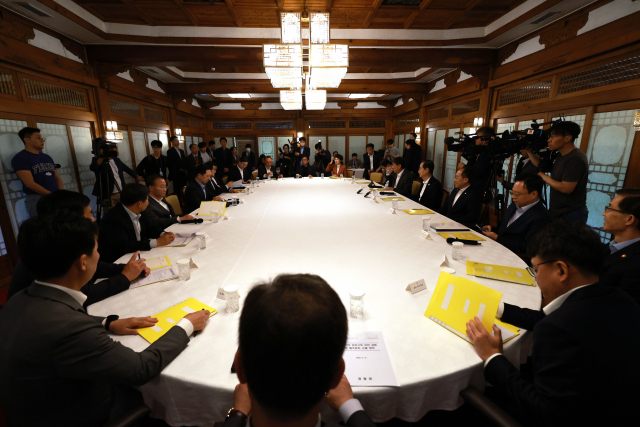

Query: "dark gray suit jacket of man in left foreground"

xmin=0 ymin=283 xmax=189 ymax=427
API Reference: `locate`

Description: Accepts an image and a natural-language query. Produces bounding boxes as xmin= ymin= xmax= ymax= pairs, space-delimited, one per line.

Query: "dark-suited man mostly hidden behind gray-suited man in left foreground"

xmin=7 ymin=190 xmax=149 ymax=307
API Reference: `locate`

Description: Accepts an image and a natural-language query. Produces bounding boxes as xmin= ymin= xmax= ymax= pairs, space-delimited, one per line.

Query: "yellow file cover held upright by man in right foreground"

xmin=424 ymin=271 xmax=502 ymax=342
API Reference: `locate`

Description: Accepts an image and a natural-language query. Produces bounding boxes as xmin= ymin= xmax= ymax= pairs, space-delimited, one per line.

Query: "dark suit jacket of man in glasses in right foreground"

xmin=484 ymin=283 xmax=640 ymax=426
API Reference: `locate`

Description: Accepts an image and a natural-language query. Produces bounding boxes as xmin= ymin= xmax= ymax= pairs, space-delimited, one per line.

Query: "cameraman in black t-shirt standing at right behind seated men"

xmin=529 ymin=121 xmax=589 ymax=224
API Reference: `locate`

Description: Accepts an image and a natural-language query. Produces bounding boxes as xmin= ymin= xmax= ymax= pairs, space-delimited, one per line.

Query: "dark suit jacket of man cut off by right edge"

xmin=600 ymin=242 xmax=640 ymax=304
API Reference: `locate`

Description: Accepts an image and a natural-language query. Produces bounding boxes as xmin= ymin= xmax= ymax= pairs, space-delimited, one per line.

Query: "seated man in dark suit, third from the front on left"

xmin=98 ymin=184 xmax=175 ymax=262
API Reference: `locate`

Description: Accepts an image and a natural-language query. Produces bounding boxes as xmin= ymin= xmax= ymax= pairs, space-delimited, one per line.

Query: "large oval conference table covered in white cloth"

xmin=89 ymin=178 xmax=541 ymax=426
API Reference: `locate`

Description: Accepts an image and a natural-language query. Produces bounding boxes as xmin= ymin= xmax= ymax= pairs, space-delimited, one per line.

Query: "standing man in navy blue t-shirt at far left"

xmin=11 ymin=127 xmax=62 ymax=217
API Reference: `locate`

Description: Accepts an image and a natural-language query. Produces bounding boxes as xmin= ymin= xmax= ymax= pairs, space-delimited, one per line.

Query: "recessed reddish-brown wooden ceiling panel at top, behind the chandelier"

xmin=74 ymin=0 xmax=524 ymax=29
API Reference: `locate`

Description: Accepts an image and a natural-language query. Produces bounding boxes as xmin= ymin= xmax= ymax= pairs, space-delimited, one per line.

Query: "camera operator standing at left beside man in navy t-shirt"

xmin=89 ymin=138 xmax=144 ymax=213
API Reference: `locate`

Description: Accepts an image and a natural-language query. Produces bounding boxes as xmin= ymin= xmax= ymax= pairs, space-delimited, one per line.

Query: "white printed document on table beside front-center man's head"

xmin=342 ymin=331 xmax=398 ymax=387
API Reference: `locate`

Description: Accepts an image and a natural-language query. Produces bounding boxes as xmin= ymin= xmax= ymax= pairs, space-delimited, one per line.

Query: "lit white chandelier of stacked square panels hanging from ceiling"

xmin=263 ymin=11 xmax=349 ymax=110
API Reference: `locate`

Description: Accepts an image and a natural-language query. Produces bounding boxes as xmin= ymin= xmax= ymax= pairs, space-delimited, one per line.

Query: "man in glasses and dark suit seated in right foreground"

xmin=467 ymin=220 xmax=640 ymax=426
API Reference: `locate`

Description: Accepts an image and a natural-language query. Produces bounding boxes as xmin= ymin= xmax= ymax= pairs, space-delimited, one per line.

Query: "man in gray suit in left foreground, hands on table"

xmin=0 ymin=216 xmax=209 ymax=427
